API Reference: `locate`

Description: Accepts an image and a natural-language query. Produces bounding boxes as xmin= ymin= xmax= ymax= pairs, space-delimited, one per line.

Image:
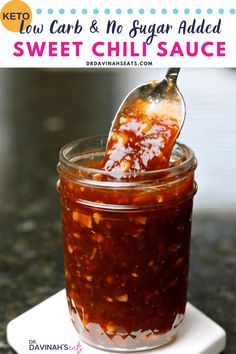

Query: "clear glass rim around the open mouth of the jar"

xmin=58 ymin=135 xmax=197 ymax=184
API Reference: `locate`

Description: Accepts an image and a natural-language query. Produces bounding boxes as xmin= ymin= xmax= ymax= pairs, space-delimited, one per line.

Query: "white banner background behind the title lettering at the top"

xmin=0 ymin=0 xmax=236 ymax=67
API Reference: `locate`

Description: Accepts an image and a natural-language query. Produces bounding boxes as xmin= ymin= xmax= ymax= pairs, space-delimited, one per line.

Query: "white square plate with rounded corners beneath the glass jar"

xmin=7 ymin=290 xmax=226 ymax=354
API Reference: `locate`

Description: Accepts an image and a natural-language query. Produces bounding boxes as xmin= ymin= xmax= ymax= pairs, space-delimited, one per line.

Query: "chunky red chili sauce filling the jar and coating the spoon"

xmin=60 ymin=102 xmax=194 ymax=347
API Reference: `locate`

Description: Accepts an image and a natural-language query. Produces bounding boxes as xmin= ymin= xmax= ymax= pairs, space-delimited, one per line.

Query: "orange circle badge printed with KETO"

xmin=0 ymin=0 xmax=32 ymax=32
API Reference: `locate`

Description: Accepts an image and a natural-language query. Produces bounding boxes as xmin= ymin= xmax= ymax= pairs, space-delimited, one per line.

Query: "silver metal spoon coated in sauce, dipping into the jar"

xmin=104 ymin=68 xmax=185 ymax=172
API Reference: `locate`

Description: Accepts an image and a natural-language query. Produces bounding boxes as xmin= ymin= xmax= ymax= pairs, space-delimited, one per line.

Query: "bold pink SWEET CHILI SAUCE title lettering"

xmin=13 ymin=41 xmax=226 ymax=58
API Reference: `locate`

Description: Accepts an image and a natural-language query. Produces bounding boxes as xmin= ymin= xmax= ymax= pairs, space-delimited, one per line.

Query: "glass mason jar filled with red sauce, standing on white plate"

xmin=57 ymin=137 xmax=197 ymax=351
